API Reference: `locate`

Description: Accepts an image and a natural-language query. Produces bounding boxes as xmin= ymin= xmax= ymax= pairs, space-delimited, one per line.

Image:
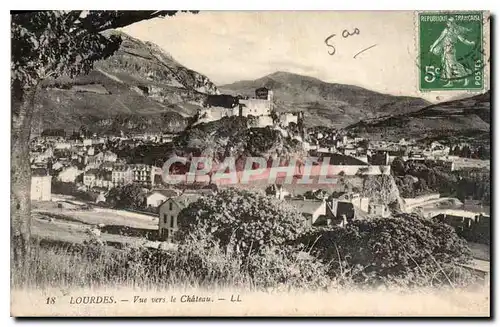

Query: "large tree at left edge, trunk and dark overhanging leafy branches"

xmin=10 ymin=11 xmax=195 ymax=264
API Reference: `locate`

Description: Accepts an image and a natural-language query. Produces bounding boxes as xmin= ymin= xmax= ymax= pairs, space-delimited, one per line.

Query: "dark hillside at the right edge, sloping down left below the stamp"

xmin=347 ymin=91 xmax=491 ymax=139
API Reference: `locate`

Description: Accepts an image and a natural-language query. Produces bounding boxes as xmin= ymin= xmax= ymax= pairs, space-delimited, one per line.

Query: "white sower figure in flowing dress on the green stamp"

xmin=430 ymin=17 xmax=475 ymax=87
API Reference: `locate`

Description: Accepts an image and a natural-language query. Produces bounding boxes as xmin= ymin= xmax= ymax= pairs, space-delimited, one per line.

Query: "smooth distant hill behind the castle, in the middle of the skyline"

xmin=219 ymin=72 xmax=430 ymax=128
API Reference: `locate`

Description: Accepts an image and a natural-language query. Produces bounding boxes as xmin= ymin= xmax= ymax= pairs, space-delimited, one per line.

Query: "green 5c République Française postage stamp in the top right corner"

xmin=418 ymin=11 xmax=484 ymax=91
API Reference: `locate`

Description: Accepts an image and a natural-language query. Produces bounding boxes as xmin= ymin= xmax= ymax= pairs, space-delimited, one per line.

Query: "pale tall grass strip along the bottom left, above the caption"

xmin=11 ymin=241 xmax=329 ymax=290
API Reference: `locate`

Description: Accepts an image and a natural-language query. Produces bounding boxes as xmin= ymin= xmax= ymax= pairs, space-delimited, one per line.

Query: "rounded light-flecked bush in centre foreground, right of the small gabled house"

xmin=177 ymin=189 xmax=307 ymax=255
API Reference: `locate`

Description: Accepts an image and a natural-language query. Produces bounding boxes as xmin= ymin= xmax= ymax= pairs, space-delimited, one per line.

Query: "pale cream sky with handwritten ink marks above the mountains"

xmin=123 ymin=11 xmax=490 ymax=102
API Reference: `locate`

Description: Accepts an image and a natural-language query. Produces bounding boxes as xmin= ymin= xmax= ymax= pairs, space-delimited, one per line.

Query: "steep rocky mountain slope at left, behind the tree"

xmin=31 ymin=31 xmax=219 ymax=136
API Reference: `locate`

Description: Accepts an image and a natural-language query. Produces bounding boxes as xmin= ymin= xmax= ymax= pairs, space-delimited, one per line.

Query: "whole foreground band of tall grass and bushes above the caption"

xmin=13 ymin=190 xmax=480 ymax=290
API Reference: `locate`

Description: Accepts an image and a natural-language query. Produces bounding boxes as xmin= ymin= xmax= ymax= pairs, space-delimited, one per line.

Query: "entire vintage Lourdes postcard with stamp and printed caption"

xmin=10 ymin=10 xmax=491 ymax=317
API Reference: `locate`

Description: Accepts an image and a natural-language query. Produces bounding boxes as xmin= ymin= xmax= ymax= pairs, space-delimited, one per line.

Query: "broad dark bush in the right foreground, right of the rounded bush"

xmin=301 ymin=215 xmax=472 ymax=284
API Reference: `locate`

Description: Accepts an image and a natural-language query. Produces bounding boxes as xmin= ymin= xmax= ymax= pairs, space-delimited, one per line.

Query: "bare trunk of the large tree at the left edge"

xmin=10 ymin=86 xmax=37 ymax=267
